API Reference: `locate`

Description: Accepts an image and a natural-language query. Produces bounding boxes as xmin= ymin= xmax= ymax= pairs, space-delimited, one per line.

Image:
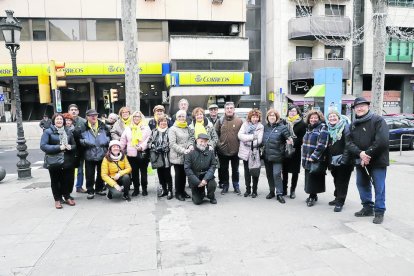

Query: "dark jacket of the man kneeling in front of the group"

xmin=184 ymin=145 xmax=217 ymax=188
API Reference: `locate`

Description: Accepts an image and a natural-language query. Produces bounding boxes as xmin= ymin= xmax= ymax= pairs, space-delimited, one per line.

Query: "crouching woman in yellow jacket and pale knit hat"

xmin=101 ymin=140 xmax=131 ymax=201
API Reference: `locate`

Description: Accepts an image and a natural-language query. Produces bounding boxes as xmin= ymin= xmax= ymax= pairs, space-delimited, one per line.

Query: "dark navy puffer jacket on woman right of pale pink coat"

xmin=263 ymin=121 xmax=290 ymax=163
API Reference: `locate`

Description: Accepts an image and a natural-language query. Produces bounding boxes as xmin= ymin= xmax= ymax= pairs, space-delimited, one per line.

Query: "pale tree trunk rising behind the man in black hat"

xmin=371 ymin=0 xmax=388 ymax=115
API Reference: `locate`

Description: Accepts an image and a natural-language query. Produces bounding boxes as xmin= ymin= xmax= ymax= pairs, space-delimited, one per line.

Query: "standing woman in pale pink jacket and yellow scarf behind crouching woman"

xmin=121 ymin=111 xmax=151 ymax=196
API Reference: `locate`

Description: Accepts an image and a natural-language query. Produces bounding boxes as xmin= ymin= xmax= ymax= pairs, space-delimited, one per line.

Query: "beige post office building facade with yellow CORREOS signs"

xmin=0 ymin=0 xmax=252 ymax=120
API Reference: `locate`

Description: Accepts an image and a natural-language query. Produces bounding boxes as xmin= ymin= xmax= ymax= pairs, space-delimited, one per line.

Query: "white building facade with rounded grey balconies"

xmin=266 ymin=0 xmax=354 ymax=114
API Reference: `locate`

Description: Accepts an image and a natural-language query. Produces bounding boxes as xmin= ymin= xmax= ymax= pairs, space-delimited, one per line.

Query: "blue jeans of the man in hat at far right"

xmin=356 ymin=166 xmax=387 ymax=213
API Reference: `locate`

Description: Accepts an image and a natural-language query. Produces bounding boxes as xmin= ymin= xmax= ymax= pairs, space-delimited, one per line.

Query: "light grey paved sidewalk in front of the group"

xmin=0 ymin=156 xmax=414 ymax=276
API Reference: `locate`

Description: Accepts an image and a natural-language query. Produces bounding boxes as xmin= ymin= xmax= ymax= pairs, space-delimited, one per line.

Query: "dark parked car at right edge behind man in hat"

xmin=384 ymin=116 xmax=414 ymax=150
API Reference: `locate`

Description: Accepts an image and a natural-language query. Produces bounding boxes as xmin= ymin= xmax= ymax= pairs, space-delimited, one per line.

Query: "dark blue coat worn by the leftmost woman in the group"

xmin=40 ymin=125 xmax=77 ymax=169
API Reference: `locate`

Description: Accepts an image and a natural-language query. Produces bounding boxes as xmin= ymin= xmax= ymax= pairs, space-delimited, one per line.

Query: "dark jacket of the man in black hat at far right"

xmin=349 ymin=114 xmax=390 ymax=168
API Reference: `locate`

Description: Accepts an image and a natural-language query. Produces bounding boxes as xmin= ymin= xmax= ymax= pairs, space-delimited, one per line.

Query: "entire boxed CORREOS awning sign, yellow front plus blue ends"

xmin=166 ymin=72 xmax=251 ymax=87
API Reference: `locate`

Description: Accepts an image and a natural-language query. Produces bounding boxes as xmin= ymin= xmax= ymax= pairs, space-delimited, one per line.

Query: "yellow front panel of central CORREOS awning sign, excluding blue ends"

xmin=179 ymin=72 xmax=245 ymax=86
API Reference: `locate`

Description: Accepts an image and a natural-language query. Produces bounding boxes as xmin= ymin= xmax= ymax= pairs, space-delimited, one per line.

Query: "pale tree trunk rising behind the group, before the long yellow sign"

xmin=121 ymin=0 xmax=141 ymax=112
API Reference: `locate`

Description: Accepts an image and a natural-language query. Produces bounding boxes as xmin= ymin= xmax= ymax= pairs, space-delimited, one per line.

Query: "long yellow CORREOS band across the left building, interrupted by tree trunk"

xmin=0 ymin=63 xmax=162 ymax=77
